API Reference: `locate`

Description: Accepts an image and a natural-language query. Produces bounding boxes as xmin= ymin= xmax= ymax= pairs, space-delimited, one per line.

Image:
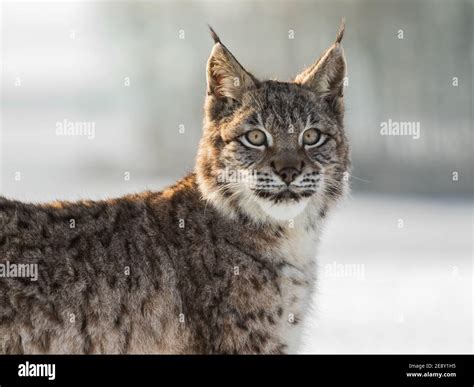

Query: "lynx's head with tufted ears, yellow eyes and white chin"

xmin=196 ymin=24 xmax=350 ymax=222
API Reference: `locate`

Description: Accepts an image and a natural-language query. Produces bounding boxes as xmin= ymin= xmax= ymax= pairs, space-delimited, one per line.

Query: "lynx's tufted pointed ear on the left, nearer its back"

xmin=207 ymin=27 xmax=258 ymax=101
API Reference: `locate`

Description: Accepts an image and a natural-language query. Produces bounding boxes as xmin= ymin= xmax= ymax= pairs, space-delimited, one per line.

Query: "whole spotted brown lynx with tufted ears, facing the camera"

xmin=0 ymin=21 xmax=350 ymax=354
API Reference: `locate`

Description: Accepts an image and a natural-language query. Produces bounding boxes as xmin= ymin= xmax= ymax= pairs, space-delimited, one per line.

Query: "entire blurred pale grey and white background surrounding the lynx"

xmin=0 ymin=0 xmax=474 ymax=353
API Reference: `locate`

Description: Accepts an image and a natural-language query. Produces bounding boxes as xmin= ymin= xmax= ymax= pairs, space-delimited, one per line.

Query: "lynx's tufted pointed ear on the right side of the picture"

xmin=295 ymin=21 xmax=346 ymax=105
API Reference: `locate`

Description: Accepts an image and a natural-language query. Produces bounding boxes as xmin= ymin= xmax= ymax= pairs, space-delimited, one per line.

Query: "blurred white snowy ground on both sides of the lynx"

xmin=2 ymin=176 xmax=473 ymax=353
